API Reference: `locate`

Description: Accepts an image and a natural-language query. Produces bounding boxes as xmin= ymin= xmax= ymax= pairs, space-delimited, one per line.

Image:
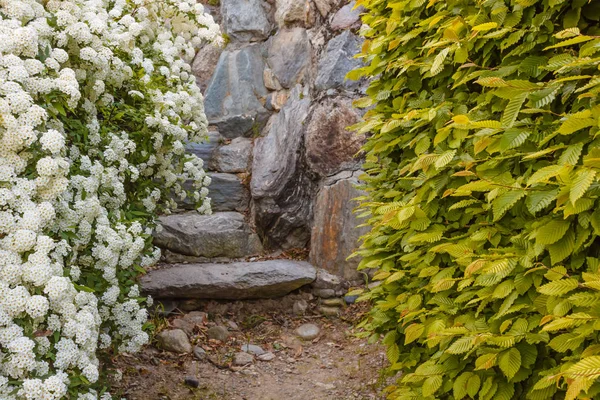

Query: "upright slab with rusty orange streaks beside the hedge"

xmin=310 ymin=173 xmax=369 ymax=280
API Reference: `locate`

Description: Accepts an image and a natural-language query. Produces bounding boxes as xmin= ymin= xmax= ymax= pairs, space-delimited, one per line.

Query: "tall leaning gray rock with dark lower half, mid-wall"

xmin=250 ymin=86 xmax=314 ymax=248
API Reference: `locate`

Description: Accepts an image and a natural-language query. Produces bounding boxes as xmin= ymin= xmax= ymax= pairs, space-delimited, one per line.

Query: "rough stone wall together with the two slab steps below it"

xmin=142 ymin=0 xmax=366 ymax=298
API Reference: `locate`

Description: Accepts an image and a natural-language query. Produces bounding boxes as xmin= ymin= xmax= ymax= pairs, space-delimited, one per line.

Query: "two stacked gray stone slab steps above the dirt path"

xmin=141 ymin=212 xmax=317 ymax=300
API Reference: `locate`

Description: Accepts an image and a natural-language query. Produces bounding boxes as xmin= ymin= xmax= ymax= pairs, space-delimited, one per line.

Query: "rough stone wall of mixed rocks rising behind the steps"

xmin=172 ymin=0 xmax=365 ymax=279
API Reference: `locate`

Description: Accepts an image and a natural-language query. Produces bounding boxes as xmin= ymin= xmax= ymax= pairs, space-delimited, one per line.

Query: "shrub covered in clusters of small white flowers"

xmin=0 ymin=0 xmax=220 ymax=400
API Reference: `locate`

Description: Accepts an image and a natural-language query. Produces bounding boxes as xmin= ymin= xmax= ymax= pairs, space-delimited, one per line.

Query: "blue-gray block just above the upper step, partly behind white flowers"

xmin=178 ymin=173 xmax=250 ymax=212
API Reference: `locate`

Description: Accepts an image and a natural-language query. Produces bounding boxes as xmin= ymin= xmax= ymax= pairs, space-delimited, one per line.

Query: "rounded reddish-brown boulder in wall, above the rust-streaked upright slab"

xmin=305 ymin=97 xmax=365 ymax=176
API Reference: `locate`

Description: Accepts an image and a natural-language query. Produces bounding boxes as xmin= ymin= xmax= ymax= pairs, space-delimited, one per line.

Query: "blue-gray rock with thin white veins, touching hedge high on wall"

xmin=315 ymin=31 xmax=362 ymax=90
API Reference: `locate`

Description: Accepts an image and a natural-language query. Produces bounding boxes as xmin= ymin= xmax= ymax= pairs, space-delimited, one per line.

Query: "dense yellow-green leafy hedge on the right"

xmin=349 ymin=0 xmax=600 ymax=400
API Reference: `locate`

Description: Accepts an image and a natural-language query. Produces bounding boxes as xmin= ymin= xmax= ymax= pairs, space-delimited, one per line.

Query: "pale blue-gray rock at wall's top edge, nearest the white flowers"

xmin=221 ymin=0 xmax=271 ymax=42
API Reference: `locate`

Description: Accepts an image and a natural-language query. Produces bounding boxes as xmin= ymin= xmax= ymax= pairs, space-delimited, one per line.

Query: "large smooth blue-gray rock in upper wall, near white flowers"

xmin=204 ymin=45 xmax=269 ymax=139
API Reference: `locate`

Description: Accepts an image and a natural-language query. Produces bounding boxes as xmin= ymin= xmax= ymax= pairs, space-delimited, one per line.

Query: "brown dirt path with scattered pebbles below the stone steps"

xmin=110 ymin=296 xmax=386 ymax=400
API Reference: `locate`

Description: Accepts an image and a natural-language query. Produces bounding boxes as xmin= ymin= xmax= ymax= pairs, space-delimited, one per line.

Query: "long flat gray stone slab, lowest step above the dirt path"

xmin=140 ymin=260 xmax=317 ymax=300
